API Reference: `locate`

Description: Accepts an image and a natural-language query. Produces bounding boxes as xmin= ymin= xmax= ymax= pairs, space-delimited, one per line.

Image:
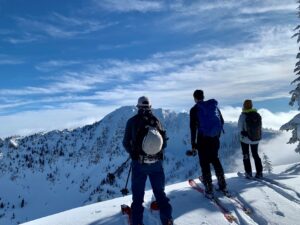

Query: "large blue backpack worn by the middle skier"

xmin=197 ymin=99 xmax=223 ymax=137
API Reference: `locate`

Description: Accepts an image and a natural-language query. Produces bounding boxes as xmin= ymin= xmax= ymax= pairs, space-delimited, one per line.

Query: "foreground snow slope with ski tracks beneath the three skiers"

xmin=20 ymin=164 xmax=300 ymax=225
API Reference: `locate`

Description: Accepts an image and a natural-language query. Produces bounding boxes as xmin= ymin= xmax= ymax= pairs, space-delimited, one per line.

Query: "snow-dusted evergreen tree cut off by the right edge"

xmin=280 ymin=0 xmax=300 ymax=153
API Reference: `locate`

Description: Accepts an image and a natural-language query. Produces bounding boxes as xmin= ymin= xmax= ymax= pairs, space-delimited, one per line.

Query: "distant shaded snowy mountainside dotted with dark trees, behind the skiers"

xmin=0 ymin=107 xmax=278 ymax=225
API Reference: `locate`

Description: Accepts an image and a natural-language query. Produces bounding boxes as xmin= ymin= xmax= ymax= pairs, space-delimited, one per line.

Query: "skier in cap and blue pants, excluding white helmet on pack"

xmin=123 ymin=96 xmax=173 ymax=225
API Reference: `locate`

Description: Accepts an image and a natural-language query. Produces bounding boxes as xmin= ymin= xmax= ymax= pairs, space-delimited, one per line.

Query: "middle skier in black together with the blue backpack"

xmin=190 ymin=90 xmax=226 ymax=194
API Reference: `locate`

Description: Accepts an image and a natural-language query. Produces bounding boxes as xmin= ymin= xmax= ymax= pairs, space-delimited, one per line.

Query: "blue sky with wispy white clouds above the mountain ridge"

xmin=0 ymin=0 xmax=299 ymax=137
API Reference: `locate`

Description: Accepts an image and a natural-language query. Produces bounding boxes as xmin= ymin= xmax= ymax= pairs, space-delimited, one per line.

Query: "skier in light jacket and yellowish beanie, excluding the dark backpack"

xmin=238 ymin=99 xmax=263 ymax=178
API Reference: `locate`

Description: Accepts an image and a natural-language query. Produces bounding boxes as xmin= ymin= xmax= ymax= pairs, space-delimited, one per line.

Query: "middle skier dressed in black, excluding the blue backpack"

xmin=190 ymin=90 xmax=227 ymax=194
